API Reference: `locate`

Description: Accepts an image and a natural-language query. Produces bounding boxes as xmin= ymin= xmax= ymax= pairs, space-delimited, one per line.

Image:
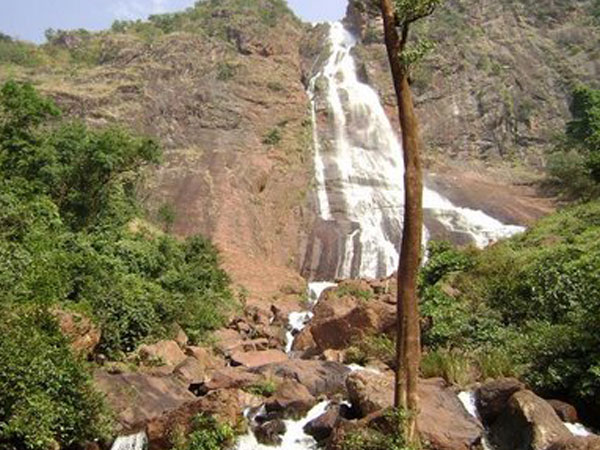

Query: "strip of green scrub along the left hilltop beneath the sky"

xmin=0 ymin=0 xmax=300 ymax=67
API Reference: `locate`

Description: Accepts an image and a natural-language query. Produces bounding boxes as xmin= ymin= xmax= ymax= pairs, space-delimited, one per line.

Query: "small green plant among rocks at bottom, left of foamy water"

xmin=171 ymin=414 xmax=235 ymax=450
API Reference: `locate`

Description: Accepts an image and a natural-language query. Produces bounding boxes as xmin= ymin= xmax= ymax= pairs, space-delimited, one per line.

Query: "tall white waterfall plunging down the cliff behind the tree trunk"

xmin=309 ymin=22 xmax=523 ymax=278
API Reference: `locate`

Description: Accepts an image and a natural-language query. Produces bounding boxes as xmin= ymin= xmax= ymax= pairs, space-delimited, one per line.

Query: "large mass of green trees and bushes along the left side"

xmin=0 ymin=82 xmax=232 ymax=450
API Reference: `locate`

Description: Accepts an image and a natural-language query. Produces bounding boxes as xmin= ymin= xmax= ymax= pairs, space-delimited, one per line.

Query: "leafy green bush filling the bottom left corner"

xmin=0 ymin=307 xmax=109 ymax=450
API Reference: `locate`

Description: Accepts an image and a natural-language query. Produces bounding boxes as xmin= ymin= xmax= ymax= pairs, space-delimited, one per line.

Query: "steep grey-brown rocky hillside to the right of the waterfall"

xmin=346 ymin=0 xmax=600 ymax=223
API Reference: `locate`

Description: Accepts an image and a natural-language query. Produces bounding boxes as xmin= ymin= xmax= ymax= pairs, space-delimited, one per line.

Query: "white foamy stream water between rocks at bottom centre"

xmin=236 ymin=402 xmax=329 ymax=450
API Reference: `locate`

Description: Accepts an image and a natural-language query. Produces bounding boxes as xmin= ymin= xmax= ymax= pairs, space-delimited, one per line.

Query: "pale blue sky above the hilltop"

xmin=0 ymin=0 xmax=347 ymax=43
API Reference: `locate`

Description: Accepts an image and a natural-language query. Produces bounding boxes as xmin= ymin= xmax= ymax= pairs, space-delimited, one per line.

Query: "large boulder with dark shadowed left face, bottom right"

xmin=489 ymin=390 xmax=571 ymax=450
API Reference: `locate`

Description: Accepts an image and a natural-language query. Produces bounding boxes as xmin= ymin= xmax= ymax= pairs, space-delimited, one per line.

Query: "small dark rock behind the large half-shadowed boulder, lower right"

xmin=475 ymin=378 xmax=525 ymax=425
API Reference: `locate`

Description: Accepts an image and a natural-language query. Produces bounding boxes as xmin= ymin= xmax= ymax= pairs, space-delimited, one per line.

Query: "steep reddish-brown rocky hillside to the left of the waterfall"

xmin=0 ymin=0 xmax=312 ymax=304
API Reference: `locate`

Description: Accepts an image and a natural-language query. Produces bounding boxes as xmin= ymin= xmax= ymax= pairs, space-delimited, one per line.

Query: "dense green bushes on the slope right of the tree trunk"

xmin=422 ymin=202 xmax=600 ymax=407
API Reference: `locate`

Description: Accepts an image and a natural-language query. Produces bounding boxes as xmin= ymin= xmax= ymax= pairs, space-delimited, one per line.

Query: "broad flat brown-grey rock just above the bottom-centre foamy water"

xmin=254 ymin=359 xmax=350 ymax=397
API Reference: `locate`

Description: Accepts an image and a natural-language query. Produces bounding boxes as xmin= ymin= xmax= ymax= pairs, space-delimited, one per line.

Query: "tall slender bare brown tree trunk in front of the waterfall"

xmin=380 ymin=0 xmax=423 ymax=444
